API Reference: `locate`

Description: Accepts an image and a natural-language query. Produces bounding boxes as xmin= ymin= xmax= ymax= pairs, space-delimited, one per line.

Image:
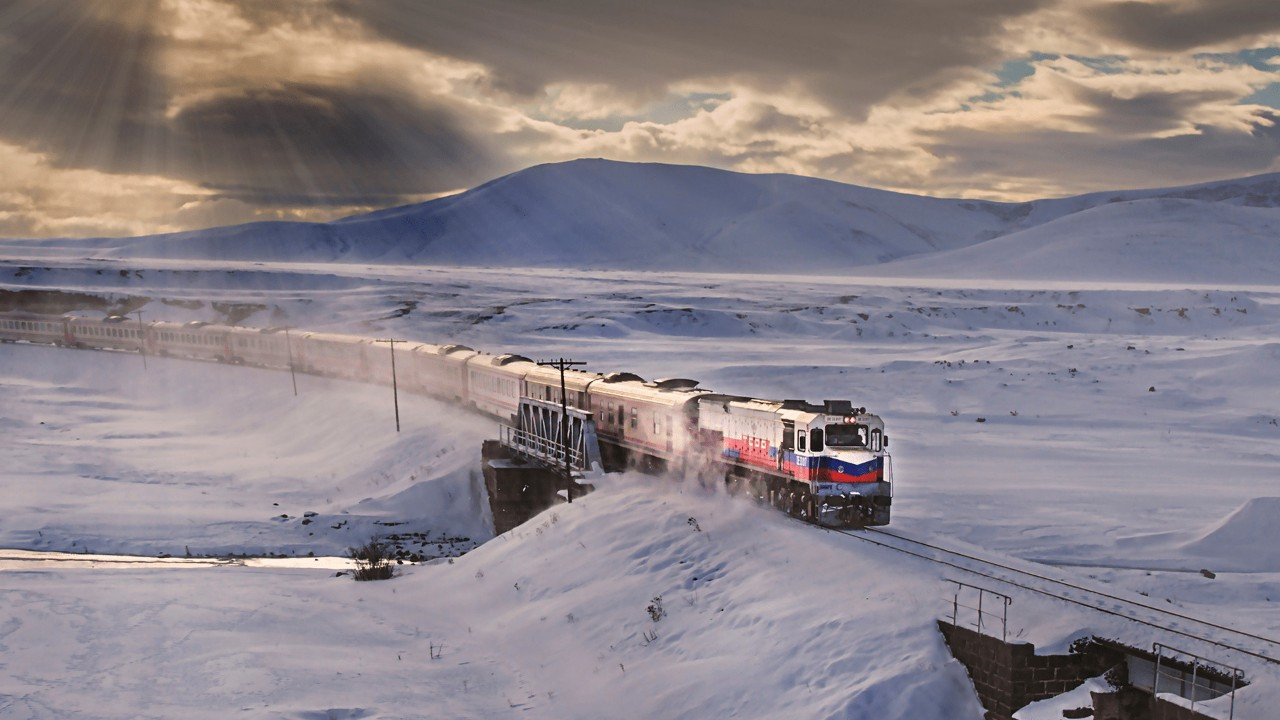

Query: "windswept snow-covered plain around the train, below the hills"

xmin=0 ymin=259 xmax=1280 ymax=720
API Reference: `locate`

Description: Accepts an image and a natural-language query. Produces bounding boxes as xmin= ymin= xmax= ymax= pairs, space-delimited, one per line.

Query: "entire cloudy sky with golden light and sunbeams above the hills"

xmin=0 ymin=0 xmax=1280 ymax=237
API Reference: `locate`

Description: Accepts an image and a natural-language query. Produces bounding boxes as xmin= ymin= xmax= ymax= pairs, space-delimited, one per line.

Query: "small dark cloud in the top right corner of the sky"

xmin=1087 ymin=0 xmax=1280 ymax=53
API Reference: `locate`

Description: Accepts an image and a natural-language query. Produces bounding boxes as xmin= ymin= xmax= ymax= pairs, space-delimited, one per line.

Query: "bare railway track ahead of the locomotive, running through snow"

xmin=826 ymin=517 xmax=1280 ymax=665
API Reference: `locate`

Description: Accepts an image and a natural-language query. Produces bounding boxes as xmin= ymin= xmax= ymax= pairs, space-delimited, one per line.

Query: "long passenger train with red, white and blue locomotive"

xmin=0 ymin=311 xmax=893 ymax=527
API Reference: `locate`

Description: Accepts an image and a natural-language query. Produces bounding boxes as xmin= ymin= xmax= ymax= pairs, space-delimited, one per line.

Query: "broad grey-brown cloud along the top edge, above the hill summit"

xmin=332 ymin=0 xmax=1044 ymax=115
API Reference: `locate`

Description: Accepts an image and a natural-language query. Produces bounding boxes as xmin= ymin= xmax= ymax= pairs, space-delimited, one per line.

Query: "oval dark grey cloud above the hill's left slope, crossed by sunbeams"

xmin=173 ymin=85 xmax=501 ymax=205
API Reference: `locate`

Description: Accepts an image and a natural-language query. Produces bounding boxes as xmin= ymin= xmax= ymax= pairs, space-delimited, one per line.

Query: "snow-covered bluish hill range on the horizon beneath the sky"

xmin=5 ymin=160 xmax=1280 ymax=279
